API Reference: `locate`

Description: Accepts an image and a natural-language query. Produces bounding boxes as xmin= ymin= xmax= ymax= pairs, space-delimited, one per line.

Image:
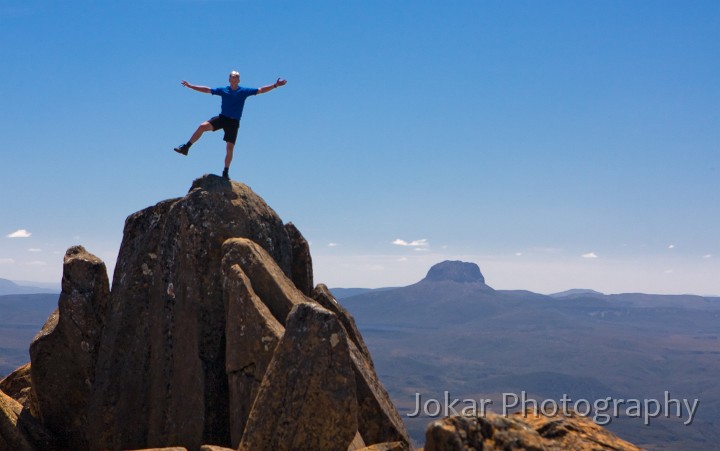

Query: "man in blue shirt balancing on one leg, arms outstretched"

xmin=175 ymin=71 xmax=287 ymax=180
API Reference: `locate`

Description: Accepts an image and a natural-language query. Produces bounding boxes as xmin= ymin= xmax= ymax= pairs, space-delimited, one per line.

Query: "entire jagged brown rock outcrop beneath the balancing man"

xmin=15 ymin=176 xmax=416 ymax=451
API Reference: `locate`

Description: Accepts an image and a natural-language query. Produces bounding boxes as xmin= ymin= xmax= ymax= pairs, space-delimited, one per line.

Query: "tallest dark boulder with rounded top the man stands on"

xmin=90 ymin=175 xmax=292 ymax=449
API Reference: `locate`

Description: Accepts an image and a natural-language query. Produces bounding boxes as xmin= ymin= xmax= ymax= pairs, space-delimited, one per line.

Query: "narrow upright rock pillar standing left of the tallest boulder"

xmin=30 ymin=246 xmax=109 ymax=449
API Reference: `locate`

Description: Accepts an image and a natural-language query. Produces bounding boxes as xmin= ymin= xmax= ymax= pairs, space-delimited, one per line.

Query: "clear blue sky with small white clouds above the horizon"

xmin=0 ymin=0 xmax=720 ymax=295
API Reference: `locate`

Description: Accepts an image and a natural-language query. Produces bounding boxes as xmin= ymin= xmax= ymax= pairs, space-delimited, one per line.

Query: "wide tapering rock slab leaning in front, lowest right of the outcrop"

xmin=239 ymin=303 xmax=358 ymax=451
